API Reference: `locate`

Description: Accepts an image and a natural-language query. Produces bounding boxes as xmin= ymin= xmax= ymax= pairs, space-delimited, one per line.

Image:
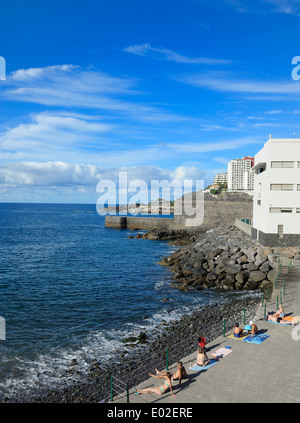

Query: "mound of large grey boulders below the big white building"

xmin=160 ymin=225 xmax=300 ymax=291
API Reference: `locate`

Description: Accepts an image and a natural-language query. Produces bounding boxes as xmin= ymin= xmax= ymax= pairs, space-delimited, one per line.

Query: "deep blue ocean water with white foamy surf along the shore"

xmin=0 ymin=203 xmax=258 ymax=398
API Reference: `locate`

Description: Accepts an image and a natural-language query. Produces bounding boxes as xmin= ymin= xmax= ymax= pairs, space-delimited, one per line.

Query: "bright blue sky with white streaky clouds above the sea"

xmin=0 ymin=0 xmax=300 ymax=203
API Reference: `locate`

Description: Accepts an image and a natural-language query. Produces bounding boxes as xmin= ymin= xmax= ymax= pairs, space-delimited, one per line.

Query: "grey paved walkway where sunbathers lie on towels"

xmin=114 ymin=261 xmax=300 ymax=404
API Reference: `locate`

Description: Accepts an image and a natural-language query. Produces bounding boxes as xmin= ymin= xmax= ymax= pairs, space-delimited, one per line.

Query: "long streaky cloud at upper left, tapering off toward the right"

xmin=0 ymin=65 xmax=190 ymax=122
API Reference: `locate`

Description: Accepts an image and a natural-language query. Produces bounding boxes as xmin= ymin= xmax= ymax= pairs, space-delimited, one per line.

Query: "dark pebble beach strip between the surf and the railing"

xmin=2 ymin=294 xmax=261 ymax=403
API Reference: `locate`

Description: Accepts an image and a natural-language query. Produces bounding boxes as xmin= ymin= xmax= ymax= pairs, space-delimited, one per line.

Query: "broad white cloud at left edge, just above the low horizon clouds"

xmin=0 ymin=113 xmax=113 ymax=161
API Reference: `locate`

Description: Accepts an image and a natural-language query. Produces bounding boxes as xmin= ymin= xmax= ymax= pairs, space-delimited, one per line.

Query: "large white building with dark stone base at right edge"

xmin=252 ymin=136 xmax=300 ymax=246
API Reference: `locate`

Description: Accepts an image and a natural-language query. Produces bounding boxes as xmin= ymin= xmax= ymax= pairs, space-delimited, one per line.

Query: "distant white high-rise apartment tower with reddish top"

xmin=228 ymin=157 xmax=254 ymax=191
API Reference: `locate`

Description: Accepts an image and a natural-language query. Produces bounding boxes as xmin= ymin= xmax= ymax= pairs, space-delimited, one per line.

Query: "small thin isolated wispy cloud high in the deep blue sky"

xmin=124 ymin=43 xmax=231 ymax=65
